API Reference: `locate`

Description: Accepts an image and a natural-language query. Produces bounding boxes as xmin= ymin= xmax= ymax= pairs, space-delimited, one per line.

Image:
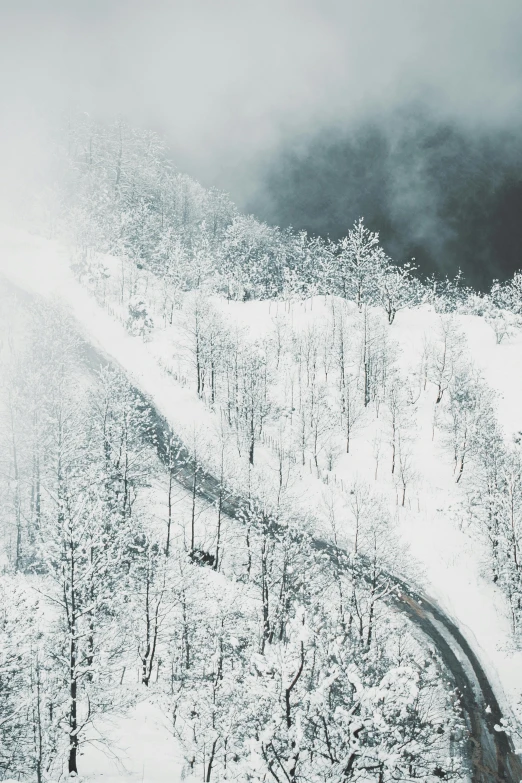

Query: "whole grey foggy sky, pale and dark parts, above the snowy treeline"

xmin=0 ymin=0 xmax=522 ymax=282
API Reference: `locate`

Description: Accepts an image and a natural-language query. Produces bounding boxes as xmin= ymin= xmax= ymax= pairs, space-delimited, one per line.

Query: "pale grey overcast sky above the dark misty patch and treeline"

xmin=0 ymin=0 xmax=522 ymax=282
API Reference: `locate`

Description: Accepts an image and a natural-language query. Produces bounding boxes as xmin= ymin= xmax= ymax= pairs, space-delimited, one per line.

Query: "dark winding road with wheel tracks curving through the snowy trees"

xmin=2 ymin=278 xmax=522 ymax=783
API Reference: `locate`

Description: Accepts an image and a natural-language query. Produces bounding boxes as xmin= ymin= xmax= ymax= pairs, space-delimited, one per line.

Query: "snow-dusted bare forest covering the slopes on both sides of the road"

xmin=0 ymin=117 xmax=522 ymax=783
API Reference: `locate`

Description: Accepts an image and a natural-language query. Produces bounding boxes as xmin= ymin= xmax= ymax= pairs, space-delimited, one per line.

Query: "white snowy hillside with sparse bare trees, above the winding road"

xmin=0 ymin=222 xmax=522 ymax=781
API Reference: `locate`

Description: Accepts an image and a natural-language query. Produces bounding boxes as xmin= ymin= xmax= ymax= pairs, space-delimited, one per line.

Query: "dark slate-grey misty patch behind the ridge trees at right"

xmin=251 ymin=112 xmax=522 ymax=287
